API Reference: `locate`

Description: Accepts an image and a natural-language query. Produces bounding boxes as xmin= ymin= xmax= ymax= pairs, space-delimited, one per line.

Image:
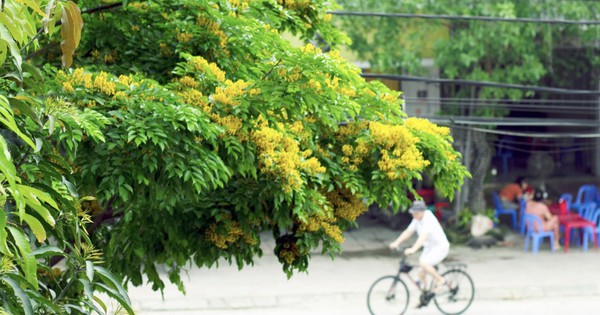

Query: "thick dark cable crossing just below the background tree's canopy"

xmin=362 ymin=73 xmax=600 ymax=96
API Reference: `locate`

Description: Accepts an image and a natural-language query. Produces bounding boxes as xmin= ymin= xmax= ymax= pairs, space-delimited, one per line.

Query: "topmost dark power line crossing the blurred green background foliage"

xmin=328 ymin=11 xmax=600 ymax=25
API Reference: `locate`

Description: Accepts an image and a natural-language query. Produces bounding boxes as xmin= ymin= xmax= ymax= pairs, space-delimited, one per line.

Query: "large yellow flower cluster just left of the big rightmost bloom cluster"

xmin=252 ymin=123 xmax=326 ymax=193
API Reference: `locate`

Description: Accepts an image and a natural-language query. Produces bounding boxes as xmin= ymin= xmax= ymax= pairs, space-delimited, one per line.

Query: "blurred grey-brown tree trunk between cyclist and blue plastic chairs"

xmin=468 ymin=131 xmax=492 ymax=212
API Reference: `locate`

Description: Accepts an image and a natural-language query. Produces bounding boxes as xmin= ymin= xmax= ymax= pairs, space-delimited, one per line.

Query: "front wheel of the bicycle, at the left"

xmin=367 ymin=276 xmax=409 ymax=315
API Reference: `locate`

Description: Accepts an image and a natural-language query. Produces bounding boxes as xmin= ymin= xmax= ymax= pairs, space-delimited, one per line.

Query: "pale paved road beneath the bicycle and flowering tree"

xmin=125 ymin=221 xmax=600 ymax=315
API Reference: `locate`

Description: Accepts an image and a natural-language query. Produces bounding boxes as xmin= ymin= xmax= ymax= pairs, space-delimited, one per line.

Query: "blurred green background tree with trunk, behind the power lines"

xmin=334 ymin=0 xmax=600 ymax=211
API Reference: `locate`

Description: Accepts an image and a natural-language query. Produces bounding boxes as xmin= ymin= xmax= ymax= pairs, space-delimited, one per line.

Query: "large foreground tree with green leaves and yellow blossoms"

xmin=0 ymin=0 xmax=467 ymax=311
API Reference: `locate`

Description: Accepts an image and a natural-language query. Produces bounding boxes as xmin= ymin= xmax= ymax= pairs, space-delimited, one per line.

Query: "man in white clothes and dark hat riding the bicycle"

xmin=389 ymin=200 xmax=450 ymax=292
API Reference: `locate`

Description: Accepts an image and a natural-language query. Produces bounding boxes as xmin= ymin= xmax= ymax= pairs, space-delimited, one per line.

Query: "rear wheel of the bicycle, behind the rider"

xmin=434 ymin=269 xmax=475 ymax=315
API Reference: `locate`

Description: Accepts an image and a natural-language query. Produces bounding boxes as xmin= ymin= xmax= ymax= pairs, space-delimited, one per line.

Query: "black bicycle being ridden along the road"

xmin=367 ymin=250 xmax=475 ymax=315
